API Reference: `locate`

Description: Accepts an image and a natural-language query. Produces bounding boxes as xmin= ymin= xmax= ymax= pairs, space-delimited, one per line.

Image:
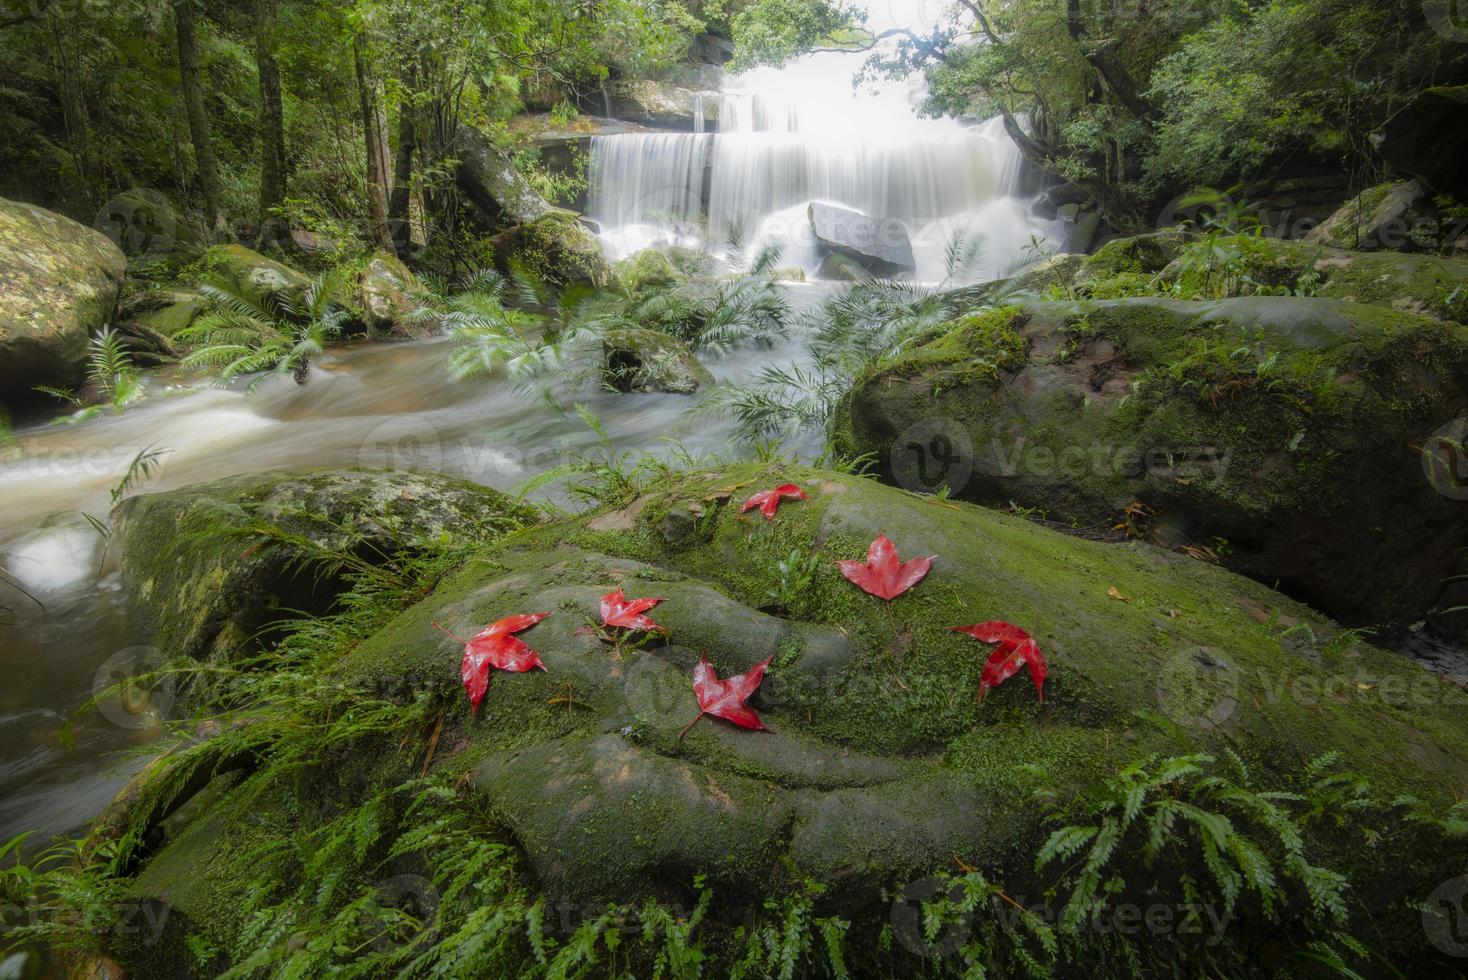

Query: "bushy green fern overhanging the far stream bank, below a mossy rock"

xmin=176 ymin=273 xmax=346 ymax=389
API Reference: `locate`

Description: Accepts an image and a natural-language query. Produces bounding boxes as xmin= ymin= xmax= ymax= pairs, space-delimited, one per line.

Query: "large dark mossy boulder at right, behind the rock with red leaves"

xmin=837 ymin=296 xmax=1468 ymax=636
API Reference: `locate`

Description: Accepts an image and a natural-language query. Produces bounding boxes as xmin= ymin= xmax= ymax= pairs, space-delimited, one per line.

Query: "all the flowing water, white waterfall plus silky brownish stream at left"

xmin=0 ymin=4 xmax=1053 ymax=841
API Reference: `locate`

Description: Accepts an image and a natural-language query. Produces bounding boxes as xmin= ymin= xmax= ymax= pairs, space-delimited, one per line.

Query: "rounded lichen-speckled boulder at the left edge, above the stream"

xmin=0 ymin=198 xmax=128 ymax=398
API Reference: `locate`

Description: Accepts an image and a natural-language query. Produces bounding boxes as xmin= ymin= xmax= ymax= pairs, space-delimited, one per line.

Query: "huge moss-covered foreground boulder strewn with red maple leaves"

xmin=108 ymin=465 xmax=1468 ymax=976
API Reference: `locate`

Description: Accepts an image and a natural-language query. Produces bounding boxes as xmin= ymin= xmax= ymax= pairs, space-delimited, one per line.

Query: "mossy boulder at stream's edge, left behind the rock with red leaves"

xmin=113 ymin=469 xmax=534 ymax=660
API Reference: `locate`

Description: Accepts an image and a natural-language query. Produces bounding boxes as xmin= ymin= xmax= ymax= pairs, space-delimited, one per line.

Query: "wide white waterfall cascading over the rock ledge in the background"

xmin=590 ymin=19 xmax=1057 ymax=282
